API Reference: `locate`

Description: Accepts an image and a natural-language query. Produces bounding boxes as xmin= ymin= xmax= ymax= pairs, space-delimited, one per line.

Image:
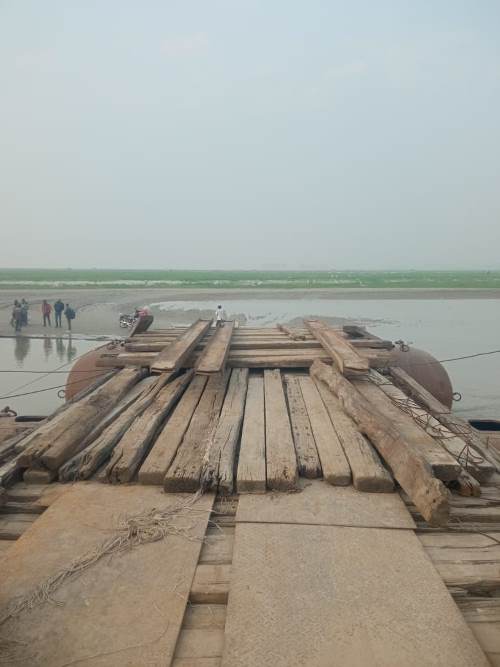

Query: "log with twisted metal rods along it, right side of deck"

xmin=370 ymin=371 xmax=495 ymax=482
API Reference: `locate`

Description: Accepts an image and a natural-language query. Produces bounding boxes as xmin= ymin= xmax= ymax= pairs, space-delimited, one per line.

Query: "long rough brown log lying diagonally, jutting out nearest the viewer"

xmin=311 ymin=362 xmax=450 ymax=526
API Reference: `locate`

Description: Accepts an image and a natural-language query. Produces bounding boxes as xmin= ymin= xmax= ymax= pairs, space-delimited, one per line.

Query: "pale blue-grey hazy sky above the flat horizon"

xmin=0 ymin=0 xmax=500 ymax=269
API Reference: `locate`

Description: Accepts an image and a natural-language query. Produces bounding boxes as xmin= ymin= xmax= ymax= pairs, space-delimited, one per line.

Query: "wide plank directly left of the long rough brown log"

xmin=314 ymin=379 xmax=394 ymax=493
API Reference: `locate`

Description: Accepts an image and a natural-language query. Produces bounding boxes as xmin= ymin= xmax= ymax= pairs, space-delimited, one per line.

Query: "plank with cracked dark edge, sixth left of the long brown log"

xmin=201 ymin=368 xmax=248 ymax=494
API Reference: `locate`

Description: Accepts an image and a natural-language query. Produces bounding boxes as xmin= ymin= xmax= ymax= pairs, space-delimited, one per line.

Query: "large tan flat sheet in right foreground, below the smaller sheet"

xmin=222 ymin=520 xmax=488 ymax=667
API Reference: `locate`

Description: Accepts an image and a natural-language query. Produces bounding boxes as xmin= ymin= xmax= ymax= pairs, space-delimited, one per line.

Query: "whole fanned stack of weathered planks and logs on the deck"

xmin=0 ymin=320 xmax=498 ymax=525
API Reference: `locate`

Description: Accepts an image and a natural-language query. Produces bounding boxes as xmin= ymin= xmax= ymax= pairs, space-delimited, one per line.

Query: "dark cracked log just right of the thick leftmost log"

xmin=59 ymin=373 xmax=172 ymax=482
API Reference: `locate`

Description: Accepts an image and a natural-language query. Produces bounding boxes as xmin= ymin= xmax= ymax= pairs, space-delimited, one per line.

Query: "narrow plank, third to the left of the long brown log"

xmin=283 ymin=374 xmax=322 ymax=479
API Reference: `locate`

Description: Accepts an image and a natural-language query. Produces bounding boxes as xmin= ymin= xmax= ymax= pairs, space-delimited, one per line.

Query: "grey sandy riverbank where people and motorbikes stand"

xmin=0 ymin=288 xmax=500 ymax=336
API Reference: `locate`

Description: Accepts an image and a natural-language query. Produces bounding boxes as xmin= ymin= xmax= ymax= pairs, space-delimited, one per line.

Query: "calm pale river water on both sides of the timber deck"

xmin=0 ymin=297 xmax=500 ymax=419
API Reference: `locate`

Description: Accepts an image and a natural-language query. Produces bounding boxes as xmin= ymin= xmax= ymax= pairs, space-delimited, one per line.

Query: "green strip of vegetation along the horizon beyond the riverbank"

xmin=0 ymin=269 xmax=500 ymax=289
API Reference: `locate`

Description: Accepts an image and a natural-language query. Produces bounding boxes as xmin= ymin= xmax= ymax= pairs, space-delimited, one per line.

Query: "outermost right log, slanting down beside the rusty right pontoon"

xmin=391 ymin=367 xmax=500 ymax=472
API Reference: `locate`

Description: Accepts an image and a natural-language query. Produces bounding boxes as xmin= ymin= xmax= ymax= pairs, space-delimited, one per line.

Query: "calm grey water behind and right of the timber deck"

xmin=154 ymin=298 xmax=500 ymax=419
